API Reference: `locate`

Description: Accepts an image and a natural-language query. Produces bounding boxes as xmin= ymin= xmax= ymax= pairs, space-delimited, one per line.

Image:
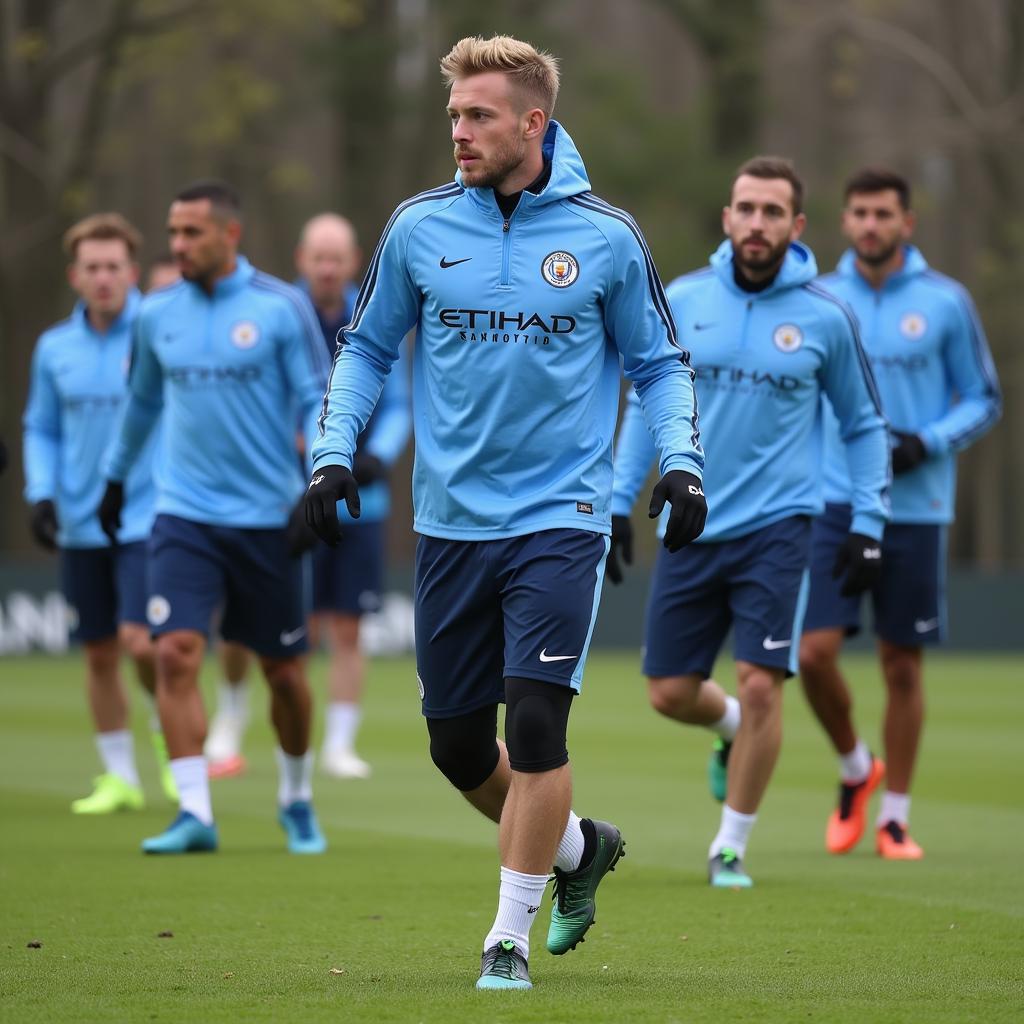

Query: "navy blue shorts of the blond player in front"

xmin=416 ymin=529 xmax=608 ymax=718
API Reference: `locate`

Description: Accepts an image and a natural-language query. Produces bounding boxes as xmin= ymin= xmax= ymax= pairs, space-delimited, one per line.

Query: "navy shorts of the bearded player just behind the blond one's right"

xmin=643 ymin=515 xmax=811 ymax=678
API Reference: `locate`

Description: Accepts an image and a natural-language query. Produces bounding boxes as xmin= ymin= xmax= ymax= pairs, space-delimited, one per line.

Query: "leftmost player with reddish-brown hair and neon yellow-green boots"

xmin=24 ymin=213 xmax=177 ymax=814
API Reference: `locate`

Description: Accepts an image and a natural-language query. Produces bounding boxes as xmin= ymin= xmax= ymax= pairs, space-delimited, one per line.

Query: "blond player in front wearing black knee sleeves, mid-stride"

xmin=306 ymin=36 xmax=706 ymax=988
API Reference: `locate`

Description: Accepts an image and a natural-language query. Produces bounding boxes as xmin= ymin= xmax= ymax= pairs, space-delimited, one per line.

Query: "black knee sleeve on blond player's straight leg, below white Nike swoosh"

xmin=505 ymin=679 xmax=573 ymax=772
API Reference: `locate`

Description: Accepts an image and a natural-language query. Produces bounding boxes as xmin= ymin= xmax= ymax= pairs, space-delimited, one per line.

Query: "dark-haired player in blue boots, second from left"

xmin=99 ymin=181 xmax=327 ymax=853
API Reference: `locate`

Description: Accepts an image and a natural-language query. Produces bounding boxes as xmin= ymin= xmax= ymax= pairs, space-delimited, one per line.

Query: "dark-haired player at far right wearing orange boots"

xmin=800 ymin=168 xmax=1001 ymax=860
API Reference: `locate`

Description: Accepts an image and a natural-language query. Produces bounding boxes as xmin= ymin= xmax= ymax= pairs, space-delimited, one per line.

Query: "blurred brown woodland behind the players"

xmin=0 ymin=0 xmax=1024 ymax=568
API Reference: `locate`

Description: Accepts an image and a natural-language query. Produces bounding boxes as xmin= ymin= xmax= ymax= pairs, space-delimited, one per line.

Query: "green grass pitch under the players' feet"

xmin=0 ymin=654 xmax=1024 ymax=1024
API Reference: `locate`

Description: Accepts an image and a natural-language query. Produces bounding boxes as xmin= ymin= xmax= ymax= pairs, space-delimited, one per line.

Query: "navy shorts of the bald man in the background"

xmin=312 ymin=522 xmax=384 ymax=615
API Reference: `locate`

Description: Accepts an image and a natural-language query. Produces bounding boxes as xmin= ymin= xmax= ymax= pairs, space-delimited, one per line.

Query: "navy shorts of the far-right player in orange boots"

xmin=804 ymin=505 xmax=946 ymax=647
